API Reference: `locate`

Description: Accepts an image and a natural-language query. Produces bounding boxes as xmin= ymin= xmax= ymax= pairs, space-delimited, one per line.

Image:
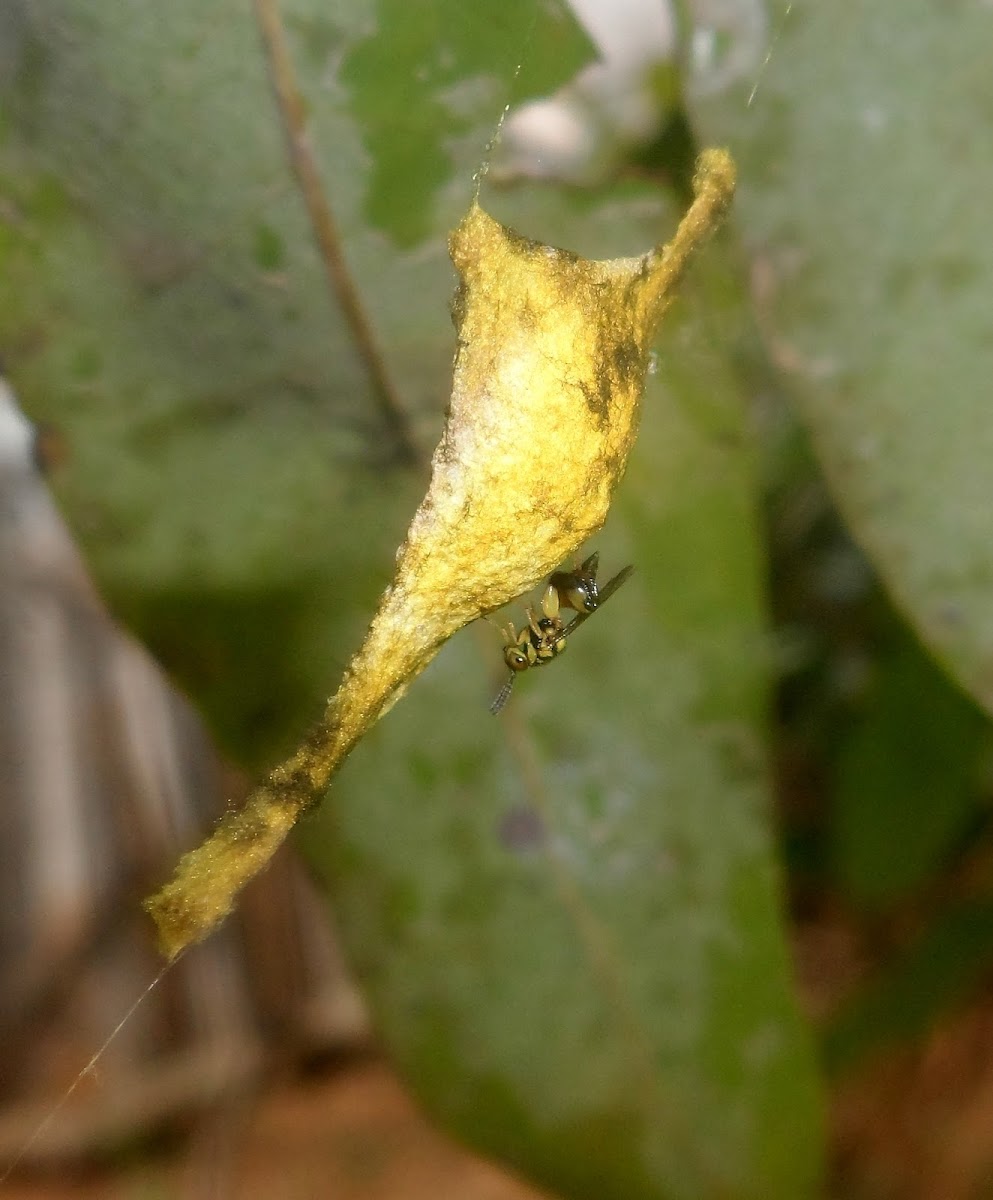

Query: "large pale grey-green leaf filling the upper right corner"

xmin=696 ymin=0 xmax=993 ymax=710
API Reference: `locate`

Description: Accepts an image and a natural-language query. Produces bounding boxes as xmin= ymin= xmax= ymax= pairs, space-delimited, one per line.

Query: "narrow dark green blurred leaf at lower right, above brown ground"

xmin=824 ymin=900 xmax=993 ymax=1073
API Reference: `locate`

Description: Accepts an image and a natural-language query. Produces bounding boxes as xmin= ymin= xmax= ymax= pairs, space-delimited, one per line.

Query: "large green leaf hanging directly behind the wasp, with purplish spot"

xmin=307 ymin=256 xmax=819 ymax=1200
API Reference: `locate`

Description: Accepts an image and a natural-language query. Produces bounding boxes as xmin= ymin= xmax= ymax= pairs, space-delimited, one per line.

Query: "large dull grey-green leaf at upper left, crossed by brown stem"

xmin=0 ymin=0 xmax=585 ymax=767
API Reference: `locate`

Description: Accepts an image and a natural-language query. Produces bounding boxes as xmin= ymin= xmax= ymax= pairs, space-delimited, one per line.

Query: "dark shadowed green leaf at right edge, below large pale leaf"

xmin=833 ymin=643 xmax=989 ymax=905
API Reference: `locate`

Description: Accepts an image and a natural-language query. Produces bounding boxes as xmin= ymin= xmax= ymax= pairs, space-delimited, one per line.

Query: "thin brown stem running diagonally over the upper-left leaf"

xmin=255 ymin=0 xmax=425 ymax=463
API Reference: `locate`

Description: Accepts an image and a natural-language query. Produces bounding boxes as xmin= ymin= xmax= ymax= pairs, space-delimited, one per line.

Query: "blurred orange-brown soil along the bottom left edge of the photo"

xmin=0 ymin=1060 xmax=551 ymax=1200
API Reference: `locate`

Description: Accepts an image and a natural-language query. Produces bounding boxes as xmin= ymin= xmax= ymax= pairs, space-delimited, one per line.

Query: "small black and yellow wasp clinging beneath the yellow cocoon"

xmin=489 ymin=551 xmax=634 ymax=716
